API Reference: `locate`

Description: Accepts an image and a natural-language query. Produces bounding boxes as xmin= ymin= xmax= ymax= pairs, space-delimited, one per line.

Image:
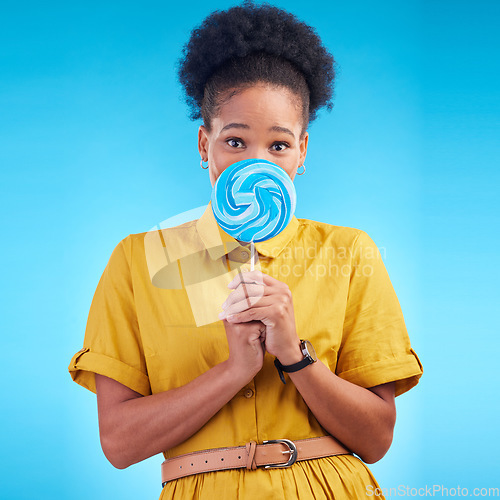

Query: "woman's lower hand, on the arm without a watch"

xmin=223 ymin=320 xmax=266 ymax=387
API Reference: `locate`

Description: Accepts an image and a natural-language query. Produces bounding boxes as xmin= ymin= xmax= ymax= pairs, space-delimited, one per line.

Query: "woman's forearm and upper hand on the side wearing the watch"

xmin=219 ymin=271 xmax=396 ymax=463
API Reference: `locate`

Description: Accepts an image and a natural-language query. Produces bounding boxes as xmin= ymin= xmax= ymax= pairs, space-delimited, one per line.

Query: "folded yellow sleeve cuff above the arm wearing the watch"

xmin=337 ymin=348 xmax=423 ymax=396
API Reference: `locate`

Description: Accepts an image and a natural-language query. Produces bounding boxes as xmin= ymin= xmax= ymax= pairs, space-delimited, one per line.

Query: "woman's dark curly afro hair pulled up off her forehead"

xmin=178 ymin=2 xmax=335 ymax=128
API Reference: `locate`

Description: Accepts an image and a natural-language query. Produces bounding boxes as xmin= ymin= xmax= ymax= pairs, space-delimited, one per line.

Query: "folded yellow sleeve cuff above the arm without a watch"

xmin=68 ymin=347 xmax=151 ymax=396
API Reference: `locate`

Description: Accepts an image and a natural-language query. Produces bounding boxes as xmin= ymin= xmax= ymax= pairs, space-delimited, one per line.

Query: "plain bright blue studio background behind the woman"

xmin=0 ymin=0 xmax=500 ymax=500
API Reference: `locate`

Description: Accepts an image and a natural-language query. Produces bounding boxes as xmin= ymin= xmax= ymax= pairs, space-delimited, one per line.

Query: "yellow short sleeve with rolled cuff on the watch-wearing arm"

xmin=336 ymin=231 xmax=423 ymax=396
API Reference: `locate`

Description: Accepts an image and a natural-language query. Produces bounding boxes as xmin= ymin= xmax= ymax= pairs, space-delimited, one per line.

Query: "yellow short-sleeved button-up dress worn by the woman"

xmin=69 ymin=203 xmax=422 ymax=500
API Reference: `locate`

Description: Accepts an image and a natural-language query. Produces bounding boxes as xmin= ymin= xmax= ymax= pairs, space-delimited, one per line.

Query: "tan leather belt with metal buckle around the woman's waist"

xmin=161 ymin=436 xmax=351 ymax=486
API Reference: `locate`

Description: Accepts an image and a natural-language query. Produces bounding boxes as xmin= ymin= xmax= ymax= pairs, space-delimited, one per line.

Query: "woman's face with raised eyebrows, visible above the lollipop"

xmin=198 ymin=84 xmax=309 ymax=186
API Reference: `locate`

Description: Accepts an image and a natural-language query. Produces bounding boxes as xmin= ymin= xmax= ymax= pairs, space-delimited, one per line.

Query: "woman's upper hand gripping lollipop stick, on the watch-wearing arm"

xmin=219 ymin=270 xmax=303 ymax=365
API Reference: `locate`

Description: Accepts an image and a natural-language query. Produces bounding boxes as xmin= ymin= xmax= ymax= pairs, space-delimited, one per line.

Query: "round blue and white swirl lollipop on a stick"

xmin=212 ymin=159 xmax=296 ymax=267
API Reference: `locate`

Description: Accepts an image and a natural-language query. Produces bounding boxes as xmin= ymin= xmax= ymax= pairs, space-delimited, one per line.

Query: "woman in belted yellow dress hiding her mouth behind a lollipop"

xmin=70 ymin=4 xmax=422 ymax=499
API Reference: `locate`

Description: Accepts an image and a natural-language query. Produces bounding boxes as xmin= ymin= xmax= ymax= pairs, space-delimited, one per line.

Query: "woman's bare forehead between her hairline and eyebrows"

xmin=214 ymin=85 xmax=302 ymax=127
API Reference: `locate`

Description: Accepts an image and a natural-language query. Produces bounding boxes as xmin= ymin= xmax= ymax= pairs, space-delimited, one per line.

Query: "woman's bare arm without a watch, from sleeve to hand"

xmin=95 ymin=321 xmax=264 ymax=469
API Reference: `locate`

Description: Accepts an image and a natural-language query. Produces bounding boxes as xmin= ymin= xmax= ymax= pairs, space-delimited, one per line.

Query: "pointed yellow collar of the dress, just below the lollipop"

xmin=196 ymin=200 xmax=299 ymax=260
